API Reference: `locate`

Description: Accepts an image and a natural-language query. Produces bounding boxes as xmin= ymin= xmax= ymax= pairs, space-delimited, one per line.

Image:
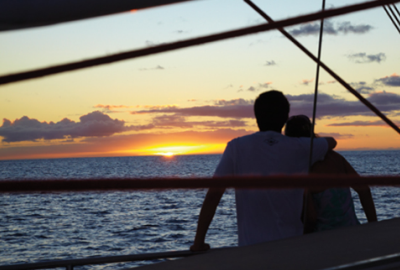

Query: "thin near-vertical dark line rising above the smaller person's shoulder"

xmin=308 ymin=0 xmax=325 ymax=172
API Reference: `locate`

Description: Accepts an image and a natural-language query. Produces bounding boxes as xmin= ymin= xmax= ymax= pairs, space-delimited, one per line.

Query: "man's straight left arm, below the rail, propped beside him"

xmin=190 ymin=188 xmax=225 ymax=251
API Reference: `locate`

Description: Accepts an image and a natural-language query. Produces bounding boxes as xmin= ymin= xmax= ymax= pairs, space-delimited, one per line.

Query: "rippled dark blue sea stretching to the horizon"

xmin=0 ymin=151 xmax=400 ymax=269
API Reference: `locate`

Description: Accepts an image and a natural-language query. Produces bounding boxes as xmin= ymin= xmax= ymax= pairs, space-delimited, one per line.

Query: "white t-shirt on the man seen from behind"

xmin=214 ymin=131 xmax=328 ymax=246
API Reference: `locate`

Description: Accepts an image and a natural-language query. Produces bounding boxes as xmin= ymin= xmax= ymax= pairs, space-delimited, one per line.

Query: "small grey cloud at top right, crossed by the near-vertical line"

xmin=289 ymin=20 xmax=373 ymax=36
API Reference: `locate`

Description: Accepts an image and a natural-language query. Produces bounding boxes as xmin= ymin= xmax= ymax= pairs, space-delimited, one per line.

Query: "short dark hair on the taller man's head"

xmin=254 ymin=90 xmax=290 ymax=131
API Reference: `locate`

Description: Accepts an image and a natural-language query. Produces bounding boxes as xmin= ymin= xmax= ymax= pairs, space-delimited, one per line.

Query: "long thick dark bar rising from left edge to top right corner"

xmin=0 ymin=0 xmax=400 ymax=85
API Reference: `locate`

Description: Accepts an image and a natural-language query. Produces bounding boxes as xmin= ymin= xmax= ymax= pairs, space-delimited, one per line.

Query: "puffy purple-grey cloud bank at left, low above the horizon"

xmin=0 ymin=111 xmax=153 ymax=143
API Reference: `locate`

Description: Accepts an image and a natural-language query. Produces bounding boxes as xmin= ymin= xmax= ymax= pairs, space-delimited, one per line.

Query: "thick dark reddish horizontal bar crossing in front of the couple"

xmin=0 ymin=174 xmax=400 ymax=192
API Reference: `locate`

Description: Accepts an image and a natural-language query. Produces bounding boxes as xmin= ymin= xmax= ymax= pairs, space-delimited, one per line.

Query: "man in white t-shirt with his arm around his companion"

xmin=190 ymin=90 xmax=336 ymax=251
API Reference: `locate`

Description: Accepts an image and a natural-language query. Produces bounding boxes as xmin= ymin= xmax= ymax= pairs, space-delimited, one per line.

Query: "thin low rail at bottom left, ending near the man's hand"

xmin=0 ymin=249 xmax=218 ymax=270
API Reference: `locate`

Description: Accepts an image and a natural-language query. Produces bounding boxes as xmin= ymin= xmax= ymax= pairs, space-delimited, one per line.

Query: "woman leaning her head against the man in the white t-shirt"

xmin=285 ymin=115 xmax=377 ymax=233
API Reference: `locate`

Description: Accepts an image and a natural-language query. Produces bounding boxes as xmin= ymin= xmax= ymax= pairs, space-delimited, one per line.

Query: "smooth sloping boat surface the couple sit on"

xmin=134 ymin=218 xmax=400 ymax=270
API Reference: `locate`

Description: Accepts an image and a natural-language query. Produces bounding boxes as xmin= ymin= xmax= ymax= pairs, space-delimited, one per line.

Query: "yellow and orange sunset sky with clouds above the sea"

xmin=0 ymin=0 xmax=400 ymax=160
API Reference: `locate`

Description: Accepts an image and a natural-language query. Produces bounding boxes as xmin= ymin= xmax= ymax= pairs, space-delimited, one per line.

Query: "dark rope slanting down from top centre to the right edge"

xmin=244 ymin=0 xmax=400 ymax=134
